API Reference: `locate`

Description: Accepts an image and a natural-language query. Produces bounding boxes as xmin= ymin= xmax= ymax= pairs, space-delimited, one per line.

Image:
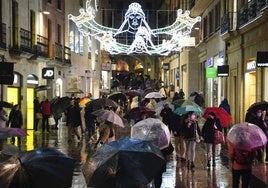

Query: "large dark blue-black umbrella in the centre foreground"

xmin=82 ymin=138 xmax=165 ymax=187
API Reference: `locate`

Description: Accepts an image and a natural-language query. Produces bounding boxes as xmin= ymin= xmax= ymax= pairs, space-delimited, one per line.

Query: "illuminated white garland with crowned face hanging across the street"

xmin=68 ymin=0 xmax=201 ymax=56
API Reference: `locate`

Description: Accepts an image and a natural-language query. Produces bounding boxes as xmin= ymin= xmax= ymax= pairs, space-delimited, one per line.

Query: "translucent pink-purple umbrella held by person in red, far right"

xmin=226 ymin=122 xmax=267 ymax=151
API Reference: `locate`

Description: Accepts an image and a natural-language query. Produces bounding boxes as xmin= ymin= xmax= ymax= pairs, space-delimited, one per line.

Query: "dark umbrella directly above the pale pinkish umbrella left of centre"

xmin=86 ymin=98 xmax=118 ymax=110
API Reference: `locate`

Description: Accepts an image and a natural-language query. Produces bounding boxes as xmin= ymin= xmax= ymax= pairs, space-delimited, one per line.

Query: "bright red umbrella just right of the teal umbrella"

xmin=203 ymin=107 xmax=232 ymax=127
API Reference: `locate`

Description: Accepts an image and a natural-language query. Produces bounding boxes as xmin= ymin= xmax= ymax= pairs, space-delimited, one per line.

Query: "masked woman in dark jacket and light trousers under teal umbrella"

xmin=182 ymin=111 xmax=201 ymax=169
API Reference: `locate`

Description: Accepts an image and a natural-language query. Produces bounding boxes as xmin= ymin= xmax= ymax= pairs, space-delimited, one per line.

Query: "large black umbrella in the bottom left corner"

xmin=0 ymin=148 xmax=75 ymax=188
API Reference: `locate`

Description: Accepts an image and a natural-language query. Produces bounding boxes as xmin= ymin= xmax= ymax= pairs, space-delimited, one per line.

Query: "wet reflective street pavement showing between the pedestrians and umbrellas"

xmin=2 ymin=122 xmax=268 ymax=188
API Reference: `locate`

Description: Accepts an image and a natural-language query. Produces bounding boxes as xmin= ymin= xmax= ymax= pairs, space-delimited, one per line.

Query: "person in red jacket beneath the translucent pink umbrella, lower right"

xmin=228 ymin=145 xmax=257 ymax=188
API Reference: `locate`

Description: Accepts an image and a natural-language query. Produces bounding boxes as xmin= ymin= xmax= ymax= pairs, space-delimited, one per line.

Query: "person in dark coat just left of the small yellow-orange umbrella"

xmin=65 ymin=100 xmax=82 ymax=142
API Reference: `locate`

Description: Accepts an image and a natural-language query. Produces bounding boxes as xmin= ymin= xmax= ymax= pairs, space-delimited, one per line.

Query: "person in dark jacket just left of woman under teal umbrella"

xmin=171 ymin=114 xmax=186 ymax=162
